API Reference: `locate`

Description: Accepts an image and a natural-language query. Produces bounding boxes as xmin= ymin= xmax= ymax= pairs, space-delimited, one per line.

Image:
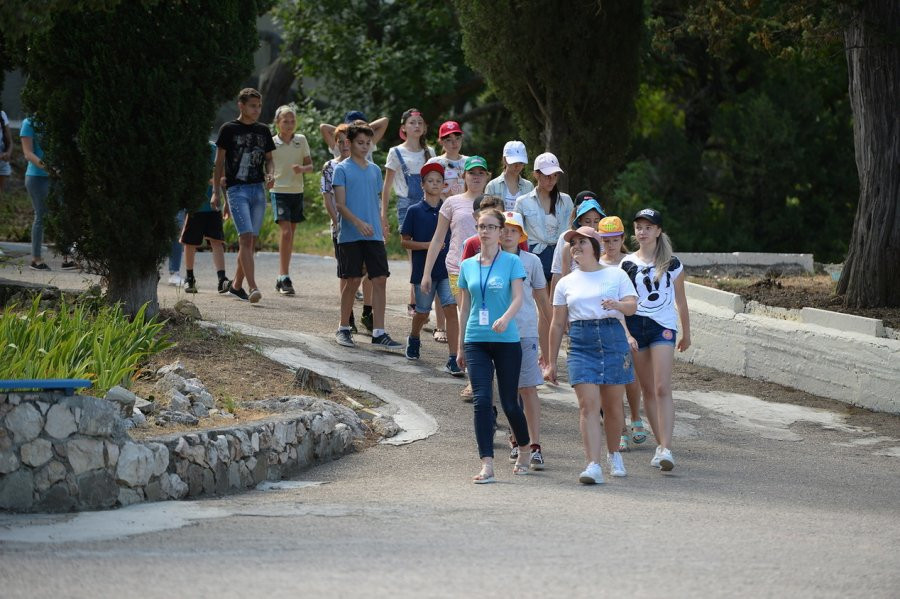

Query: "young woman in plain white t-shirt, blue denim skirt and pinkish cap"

xmin=546 ymin=227 xmax=637 ymax=484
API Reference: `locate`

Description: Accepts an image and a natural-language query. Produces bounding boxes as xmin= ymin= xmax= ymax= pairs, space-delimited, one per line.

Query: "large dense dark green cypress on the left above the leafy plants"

xmin=24 ymin=0 xmax=271 ymax=313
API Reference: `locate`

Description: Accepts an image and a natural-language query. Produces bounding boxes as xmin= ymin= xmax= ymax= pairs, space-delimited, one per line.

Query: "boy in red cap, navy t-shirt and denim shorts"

xmin=400 ymin=162 xmax=463 ymax=377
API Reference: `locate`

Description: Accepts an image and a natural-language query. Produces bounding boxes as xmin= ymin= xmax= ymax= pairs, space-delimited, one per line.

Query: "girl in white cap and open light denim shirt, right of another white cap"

xmin=515 ymin=152 xmax=574 ymax=288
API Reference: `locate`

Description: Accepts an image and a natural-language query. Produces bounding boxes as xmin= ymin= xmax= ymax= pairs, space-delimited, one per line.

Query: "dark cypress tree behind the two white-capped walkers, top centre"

xmin=456 ymin=0 xmax=643 ymax=189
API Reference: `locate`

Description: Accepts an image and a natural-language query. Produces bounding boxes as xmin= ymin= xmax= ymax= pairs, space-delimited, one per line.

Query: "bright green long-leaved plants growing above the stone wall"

xmin=0 ymin=297 xmax=172 ymax=395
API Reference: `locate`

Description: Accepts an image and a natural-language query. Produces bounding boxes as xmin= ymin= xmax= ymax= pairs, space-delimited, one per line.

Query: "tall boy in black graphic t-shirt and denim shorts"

xmin=209 ymin=87 xmax=275 ymax=304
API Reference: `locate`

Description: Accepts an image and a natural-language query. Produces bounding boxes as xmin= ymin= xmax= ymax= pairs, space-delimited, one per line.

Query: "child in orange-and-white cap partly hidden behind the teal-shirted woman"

xmin=500 ymin=212 xmax=551 ymax=470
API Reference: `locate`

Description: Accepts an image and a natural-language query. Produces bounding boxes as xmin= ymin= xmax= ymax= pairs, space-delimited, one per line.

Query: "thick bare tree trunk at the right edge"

xmin=837 ymin=0 xmax=900 ymax=308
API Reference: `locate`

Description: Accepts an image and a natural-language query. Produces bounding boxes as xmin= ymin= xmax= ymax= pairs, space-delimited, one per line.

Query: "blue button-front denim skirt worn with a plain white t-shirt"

xmin=566 ymin=318 xmax=634 ymax=387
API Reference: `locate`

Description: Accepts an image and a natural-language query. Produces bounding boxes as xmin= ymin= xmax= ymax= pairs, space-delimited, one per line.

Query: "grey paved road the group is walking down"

xmin=0 ymin=246 xmax=900 ymax=597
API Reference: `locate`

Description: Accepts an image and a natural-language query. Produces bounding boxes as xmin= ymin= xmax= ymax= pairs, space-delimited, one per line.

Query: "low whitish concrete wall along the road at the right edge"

xmin=676 ymin=283 xmax=900 ymax=414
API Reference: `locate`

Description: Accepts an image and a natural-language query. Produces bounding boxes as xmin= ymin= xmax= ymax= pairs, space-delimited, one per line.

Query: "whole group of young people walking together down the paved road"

xmin=182 ymin=90 xmax=690 ymax=484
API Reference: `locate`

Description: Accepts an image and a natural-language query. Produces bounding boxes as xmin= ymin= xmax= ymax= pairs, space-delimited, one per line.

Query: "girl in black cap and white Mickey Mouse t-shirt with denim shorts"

xmin=621 ymin=208 xmax=691 ymax=471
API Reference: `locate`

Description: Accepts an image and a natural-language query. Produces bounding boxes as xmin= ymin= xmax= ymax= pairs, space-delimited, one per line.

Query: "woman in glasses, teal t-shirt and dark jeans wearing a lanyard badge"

xmin=457 ymin=208 xmax=531 ymax=484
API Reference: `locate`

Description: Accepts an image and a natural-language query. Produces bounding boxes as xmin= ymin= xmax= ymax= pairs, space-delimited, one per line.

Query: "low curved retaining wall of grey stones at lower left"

xmin=0 ymin=393 xmax=363 ymax=512
